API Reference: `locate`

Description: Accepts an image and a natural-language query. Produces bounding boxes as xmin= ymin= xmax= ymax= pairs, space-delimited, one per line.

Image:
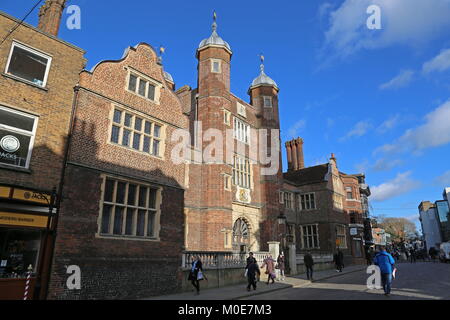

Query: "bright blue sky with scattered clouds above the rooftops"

xmin=0 ymin=0 xmax=450 ymax=230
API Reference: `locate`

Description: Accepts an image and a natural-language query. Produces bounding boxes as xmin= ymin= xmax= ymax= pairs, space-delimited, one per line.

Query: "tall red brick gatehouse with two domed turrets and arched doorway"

xmin=177 ymin=16 xmax=282 ymax=252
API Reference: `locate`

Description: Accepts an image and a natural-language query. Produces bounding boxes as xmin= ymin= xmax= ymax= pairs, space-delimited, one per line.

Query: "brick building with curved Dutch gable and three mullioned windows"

xmin=49 ymin=43 xmax=188 ymax=299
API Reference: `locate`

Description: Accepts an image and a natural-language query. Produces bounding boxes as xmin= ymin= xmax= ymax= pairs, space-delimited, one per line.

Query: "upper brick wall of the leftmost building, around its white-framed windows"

xmin=0 ymin=12 xmax=85 ymax=191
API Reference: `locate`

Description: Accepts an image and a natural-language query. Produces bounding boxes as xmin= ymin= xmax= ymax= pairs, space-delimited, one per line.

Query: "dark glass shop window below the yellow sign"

xmin=0 ymin=227 xmax=42 ymax=279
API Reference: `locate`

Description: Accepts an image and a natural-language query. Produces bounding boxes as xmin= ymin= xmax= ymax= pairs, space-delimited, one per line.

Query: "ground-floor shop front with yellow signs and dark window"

xmin=0 ymin=186 xmax=55 ymax=300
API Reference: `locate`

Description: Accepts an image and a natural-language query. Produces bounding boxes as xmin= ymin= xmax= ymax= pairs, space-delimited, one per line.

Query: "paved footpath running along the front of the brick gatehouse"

xmin=145 ymin=266 xmax=366 ymax=301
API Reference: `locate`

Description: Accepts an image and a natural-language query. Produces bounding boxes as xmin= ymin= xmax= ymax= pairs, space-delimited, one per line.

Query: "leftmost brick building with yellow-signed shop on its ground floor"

xmin=0 ymin=1 xmax=85 ymax=299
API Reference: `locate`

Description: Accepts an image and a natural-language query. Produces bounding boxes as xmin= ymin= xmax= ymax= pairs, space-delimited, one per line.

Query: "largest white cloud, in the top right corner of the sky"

xmin=322 ymin=0 xmax=450 ymax=59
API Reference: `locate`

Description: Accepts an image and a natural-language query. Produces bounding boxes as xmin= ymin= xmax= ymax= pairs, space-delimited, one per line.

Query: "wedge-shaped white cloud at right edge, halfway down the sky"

xmin=375 ymin=99 xmax=450 ymax=154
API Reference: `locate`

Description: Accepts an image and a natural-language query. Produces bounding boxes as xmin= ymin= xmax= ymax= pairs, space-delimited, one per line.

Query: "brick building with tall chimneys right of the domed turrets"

xmin=280 ymin=139 xmax=370 ymax=264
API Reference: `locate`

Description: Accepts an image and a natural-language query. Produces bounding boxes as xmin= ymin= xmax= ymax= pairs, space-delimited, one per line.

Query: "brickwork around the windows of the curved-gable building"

xmin=49 ymin=44 xmax=188 ymax=299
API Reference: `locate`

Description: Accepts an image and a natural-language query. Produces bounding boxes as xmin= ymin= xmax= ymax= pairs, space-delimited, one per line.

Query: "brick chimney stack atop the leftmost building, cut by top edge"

xmin=38 ymin=0 xmax=66 ymax=37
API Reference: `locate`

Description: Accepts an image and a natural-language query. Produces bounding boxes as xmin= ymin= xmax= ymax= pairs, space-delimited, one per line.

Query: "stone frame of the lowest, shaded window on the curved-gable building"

xmin=96 ymin=175 xmax=162 ymax=242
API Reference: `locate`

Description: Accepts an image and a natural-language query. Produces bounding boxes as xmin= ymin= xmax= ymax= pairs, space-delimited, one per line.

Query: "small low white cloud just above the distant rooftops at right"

xmin=370 ymin=171 xmax=420 ymax=202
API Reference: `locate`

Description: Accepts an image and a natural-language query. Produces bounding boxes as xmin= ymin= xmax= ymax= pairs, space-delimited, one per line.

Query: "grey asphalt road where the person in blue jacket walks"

xmin=246 ymin=262 xmax=450 ymax=300
